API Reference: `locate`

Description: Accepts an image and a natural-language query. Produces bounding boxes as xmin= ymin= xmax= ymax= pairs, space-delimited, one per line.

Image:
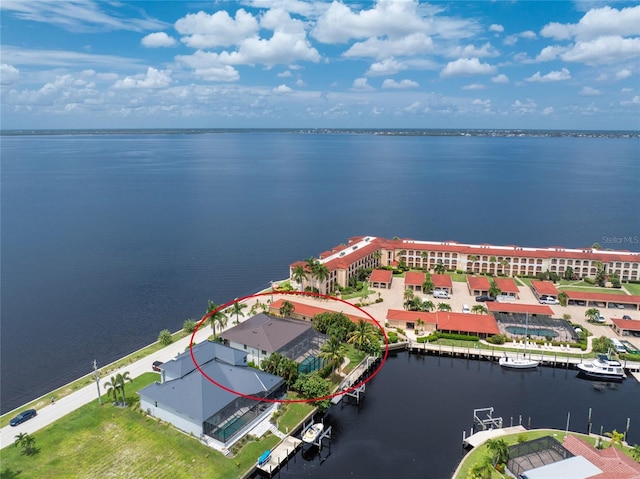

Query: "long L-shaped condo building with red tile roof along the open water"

xmin=290 ymin=236 xmax=640 ymax=293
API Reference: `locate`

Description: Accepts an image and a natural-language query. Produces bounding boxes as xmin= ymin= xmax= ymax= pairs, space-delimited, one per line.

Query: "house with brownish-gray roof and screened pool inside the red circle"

xmin=220 ymin=313 xmax=327 ymax=364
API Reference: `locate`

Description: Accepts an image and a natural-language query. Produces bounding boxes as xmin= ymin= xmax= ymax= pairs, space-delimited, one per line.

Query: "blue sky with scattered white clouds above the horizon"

xmin=0 ymin=0 xmax=640 ymax=130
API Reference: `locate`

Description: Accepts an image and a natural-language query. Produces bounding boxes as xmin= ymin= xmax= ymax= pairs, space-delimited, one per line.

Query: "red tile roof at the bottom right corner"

xmin=563 ymin=436 xmax=640 ymax=479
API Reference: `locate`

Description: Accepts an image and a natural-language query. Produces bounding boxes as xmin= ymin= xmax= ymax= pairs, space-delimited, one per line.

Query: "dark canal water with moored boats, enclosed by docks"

xmin=262 ymin=352 xmax=640 ymax=479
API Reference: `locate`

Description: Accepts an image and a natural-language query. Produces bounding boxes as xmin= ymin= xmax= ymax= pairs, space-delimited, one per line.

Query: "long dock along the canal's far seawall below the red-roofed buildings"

xmin=407 ymin=341 xmax=640 ymax=378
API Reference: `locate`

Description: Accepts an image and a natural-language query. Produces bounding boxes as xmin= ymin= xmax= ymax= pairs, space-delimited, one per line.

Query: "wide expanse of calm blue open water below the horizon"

xmin=0 ymin=132 xmax=640 ymax=411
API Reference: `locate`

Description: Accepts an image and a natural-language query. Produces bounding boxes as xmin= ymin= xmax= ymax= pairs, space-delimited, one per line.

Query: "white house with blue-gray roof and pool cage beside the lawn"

xmin=138 ymin=341 xmax=286 ymax=446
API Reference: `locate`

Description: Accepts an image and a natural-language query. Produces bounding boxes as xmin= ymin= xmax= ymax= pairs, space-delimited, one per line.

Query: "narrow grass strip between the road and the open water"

xmin=0 ymin=330 xmax=190 ymax=427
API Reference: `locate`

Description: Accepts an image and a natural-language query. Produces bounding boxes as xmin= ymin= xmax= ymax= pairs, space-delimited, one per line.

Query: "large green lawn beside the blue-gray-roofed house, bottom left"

xmin=0 ymin=373 xmax=278 ymax=479
